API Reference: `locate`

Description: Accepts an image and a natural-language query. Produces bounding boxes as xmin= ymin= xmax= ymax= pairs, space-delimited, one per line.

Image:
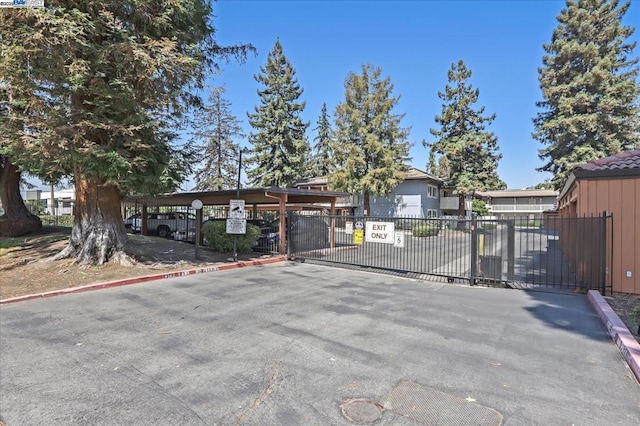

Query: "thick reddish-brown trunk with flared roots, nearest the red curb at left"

xmin=54 ymin=175 xmax=133 ymax=265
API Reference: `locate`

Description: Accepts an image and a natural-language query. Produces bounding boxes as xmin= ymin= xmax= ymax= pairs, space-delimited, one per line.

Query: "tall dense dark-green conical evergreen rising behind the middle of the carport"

xmin=247 ymin=40 xmax=310 ymax=187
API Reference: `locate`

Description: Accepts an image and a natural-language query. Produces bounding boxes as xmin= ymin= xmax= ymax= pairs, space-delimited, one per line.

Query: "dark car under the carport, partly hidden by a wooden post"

xmin=254 ymin=215 xmax=330 ymax=252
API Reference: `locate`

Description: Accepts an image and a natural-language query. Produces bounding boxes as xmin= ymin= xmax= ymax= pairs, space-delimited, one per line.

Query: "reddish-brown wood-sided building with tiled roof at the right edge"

xmin=558 ymin=148 xmax=640 ymax=294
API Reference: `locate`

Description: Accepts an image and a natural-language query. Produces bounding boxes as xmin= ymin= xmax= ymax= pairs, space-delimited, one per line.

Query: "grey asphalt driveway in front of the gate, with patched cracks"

xmin=0 ymin=263 xmax=640 ymax=426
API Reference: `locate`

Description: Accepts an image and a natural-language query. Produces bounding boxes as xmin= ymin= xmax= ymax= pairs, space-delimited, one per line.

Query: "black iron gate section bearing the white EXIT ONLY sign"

xmin=288 ymin=214 xmax=472 ymax=281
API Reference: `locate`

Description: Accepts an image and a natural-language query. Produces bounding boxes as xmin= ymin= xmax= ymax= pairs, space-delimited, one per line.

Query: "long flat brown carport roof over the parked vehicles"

xmin=126 ymin=187 xmax=349 ymax=206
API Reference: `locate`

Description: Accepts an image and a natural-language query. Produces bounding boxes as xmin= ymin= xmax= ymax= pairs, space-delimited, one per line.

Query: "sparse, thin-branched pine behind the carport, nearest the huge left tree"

xmin=192 ymin=87 xmax=244 ymax=191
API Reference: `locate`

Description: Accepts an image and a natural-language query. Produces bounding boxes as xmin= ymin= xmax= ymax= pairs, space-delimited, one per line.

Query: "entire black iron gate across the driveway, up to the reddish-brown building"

xmin=287 ymin=213 xmax=612 ymax=294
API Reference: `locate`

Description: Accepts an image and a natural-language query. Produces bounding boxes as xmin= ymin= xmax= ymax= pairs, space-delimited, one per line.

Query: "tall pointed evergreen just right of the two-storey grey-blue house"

xmin=423 ymin=60 xmax=506 ymax=217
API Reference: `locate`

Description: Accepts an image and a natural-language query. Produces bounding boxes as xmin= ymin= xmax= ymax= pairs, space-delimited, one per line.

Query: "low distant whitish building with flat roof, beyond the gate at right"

xmin=475 ymin=189 xmax=558 ymax=220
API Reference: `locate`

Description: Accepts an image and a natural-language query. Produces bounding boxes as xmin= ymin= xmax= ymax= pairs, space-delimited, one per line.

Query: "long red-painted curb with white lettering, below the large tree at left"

xmin=0 ymin=256 xmax=287 ymax=305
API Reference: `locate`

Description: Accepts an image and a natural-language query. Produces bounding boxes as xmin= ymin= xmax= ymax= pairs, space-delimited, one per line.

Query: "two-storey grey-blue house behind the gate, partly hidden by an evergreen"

xmin=294 ymin=167 xmax=443 ymax=217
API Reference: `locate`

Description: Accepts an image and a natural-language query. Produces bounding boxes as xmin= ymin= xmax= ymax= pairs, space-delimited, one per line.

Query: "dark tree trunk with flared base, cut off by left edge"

xmin=0 ymin=156 xmax=42 ymax=237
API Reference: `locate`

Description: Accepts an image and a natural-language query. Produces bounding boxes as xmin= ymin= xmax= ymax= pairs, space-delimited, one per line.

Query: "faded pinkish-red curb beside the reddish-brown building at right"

xmin=588 ymin=290 xmax=640 ymax=382
